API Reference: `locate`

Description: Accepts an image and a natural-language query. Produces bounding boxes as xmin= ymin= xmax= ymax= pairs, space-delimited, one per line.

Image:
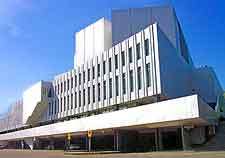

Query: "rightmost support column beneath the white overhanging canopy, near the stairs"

xmin=181 ymin=126 xmax=191 ymax=150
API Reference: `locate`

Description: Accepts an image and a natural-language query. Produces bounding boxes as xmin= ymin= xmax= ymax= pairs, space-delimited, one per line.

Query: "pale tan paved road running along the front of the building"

xmin=0 ymin=150 xmax=225 ymax=158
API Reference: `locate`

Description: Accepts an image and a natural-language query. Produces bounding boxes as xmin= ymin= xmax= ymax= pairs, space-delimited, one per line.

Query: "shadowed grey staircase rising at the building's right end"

xmin=194 ymin=122 xmax=225 ymax=151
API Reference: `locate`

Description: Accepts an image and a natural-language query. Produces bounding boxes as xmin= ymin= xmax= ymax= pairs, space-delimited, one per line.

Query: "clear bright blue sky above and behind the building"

xmin=0 ymin=0 xmax=225 ymax=113
